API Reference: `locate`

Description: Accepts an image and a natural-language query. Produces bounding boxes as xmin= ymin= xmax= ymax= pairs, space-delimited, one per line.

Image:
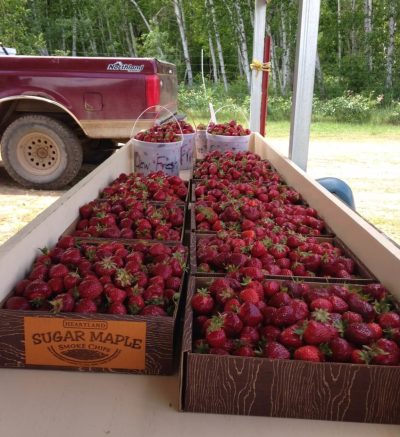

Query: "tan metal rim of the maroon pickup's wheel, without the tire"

xmin=17 ymin=132 xmax=61 ymax=176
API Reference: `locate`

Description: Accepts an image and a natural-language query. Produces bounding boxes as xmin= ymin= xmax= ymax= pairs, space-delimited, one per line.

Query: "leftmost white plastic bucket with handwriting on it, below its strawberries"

xmin=130 ymin=138 xmax=182 ymax=176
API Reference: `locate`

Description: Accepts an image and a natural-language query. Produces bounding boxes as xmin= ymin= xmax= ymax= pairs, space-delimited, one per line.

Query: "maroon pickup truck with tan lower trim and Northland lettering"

xmin=0 ymin=56 xmax=177 ymax=189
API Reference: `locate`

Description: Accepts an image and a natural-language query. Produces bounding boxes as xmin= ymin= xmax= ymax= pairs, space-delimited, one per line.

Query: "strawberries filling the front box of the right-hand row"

xmin=191 ymin=277 xmax=400 ymax=365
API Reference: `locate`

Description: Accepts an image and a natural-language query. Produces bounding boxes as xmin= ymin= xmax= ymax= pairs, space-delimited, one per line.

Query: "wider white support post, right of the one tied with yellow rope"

xmin=289 ymin=0 xmax=321 ymax=171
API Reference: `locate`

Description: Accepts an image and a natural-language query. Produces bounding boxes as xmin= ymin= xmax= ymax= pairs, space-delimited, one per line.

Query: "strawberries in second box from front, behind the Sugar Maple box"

xmin=72 ymin=197 xmax=185 ymax=241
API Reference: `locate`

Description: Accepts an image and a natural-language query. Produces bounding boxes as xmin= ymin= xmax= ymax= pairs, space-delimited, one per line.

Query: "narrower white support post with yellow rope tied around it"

xmin=250 ymin=0 xmax=267 ymax=132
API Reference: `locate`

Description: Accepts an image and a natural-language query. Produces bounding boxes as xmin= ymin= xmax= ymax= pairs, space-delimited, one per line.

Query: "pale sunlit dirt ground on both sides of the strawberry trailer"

xmin=0 ymin=138 xmax=400 ymax=244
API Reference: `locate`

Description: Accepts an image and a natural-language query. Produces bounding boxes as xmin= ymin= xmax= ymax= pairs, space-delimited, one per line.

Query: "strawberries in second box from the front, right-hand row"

xmin=196 ymin=228 xmax=357 ymax=280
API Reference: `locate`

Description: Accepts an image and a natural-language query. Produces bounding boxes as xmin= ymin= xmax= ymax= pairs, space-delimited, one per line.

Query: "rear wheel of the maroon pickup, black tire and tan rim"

xmin=1 ymin=115 xmax=82 ymax=190
